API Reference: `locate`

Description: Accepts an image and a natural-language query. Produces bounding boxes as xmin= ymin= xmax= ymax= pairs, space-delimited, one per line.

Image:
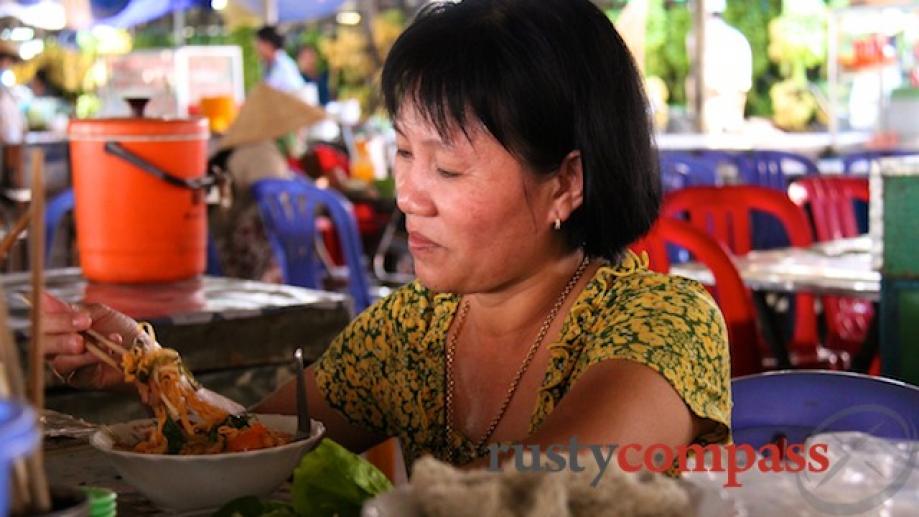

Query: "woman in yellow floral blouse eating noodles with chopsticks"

xmin=43 ymin=0 xmax=731 ymax=465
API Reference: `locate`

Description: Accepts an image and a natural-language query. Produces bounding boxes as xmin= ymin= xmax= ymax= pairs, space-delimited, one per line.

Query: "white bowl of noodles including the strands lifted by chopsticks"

xmin=77 ymin=323 xmax=325 ymax=511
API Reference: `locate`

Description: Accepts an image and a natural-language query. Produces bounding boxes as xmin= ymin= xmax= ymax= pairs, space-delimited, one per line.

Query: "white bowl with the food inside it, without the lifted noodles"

xmin=90 ymin=414 xmax=325 ymax=511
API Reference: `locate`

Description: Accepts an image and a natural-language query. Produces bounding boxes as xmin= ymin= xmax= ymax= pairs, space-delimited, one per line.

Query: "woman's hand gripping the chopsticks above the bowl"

xmin=41 ymin=293 xmax=143 ymax=389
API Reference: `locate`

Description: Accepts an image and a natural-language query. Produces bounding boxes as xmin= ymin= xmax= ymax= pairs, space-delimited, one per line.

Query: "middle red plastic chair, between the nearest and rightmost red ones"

xmin=662 ymin=186 xmax=832 ymax=368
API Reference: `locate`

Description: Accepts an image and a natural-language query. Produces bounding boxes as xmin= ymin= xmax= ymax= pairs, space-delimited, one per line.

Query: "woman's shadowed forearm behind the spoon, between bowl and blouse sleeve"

xmin=250 ymin=366 xmax=387 ymax=453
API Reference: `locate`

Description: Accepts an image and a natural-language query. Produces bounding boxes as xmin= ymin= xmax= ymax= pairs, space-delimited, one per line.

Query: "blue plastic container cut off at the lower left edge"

xmin=0 ymin=400 xmax=38 ymax=515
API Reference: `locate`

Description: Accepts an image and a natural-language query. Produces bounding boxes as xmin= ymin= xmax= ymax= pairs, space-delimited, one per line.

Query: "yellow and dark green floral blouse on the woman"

xmin=315 ymin=253 xmax=731 ymax=465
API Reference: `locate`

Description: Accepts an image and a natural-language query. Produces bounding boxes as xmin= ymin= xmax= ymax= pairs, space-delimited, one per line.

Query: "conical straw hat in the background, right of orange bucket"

xmin=220 ymin=83 xmax=326 ymax=149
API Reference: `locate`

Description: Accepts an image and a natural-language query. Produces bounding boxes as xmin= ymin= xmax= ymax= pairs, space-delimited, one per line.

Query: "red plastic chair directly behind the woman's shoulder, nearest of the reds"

xmin=632 ymin=217 xmax=771 ymax=377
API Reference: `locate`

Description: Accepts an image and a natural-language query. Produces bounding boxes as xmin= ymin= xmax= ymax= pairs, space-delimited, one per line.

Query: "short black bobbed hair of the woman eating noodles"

xmin=382 ymin=0 xmax=661 ymax=260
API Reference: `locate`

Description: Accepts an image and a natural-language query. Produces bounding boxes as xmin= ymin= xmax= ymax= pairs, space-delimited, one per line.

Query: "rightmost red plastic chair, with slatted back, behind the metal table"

xmin=788 ymin=177 xmax=874 ymax=355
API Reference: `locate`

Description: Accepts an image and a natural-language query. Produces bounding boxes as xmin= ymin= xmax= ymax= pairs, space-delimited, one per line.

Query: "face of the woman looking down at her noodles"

xmin=395 ymin=103 xmax=562 ymax=293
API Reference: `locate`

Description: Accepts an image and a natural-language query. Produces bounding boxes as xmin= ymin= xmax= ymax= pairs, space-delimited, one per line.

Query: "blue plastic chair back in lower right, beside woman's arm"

xmin=731 ymin=370 xmax=919 ymax=448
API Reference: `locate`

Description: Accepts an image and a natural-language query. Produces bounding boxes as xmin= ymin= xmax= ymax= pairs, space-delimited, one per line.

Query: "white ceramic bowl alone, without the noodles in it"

xmin=90 ymin=415 xmax=325 ymax=511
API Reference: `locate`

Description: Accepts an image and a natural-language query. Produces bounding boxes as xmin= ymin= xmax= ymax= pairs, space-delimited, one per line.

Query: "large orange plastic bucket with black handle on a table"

xmin=69 ymin=118 xmax=212 ymax=283
